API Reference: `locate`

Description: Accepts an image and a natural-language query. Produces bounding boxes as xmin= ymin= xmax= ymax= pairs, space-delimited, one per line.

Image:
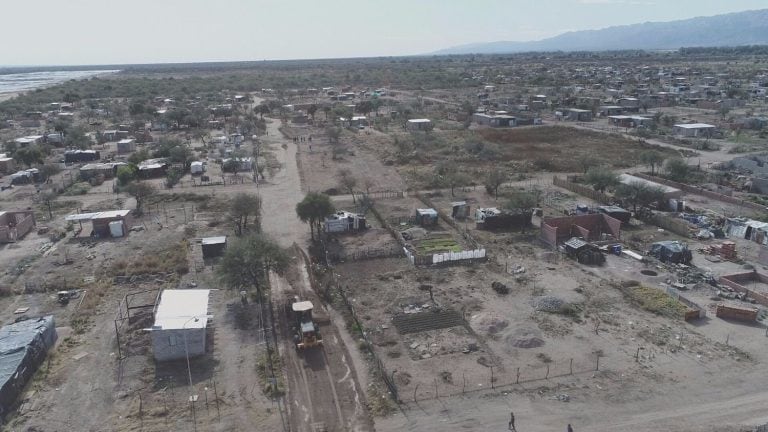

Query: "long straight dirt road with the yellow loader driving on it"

xmin=258 ymin=120 xmax=373 ymax=432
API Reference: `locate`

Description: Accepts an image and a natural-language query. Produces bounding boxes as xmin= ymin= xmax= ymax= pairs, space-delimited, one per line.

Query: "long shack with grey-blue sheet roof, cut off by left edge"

xmin=0 ymin=315 xmax=57 ymax=416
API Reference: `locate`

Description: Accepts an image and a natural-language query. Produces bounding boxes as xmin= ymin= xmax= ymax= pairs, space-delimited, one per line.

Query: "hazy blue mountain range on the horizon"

xmin=432 ymin=9 xmax=768 ymax=55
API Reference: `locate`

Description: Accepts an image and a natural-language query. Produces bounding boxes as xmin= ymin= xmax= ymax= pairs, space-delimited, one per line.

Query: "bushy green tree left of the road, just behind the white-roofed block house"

xmin=216 ymin=233 xmax=289 ymax=301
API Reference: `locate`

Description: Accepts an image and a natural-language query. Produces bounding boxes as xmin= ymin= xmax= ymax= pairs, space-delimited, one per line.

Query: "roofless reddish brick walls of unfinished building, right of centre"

xmin=540 ymin=213 xmax=621 ymax=248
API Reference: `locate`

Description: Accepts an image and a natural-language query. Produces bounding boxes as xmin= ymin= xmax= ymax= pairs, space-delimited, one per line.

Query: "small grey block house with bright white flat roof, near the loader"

xmin=150 ymin=289 xmax=210 ymax=361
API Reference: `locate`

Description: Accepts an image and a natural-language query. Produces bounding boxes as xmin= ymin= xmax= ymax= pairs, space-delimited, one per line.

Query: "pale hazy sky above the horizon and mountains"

xmin=0 ymin=0 xmax=768 ymax=65
